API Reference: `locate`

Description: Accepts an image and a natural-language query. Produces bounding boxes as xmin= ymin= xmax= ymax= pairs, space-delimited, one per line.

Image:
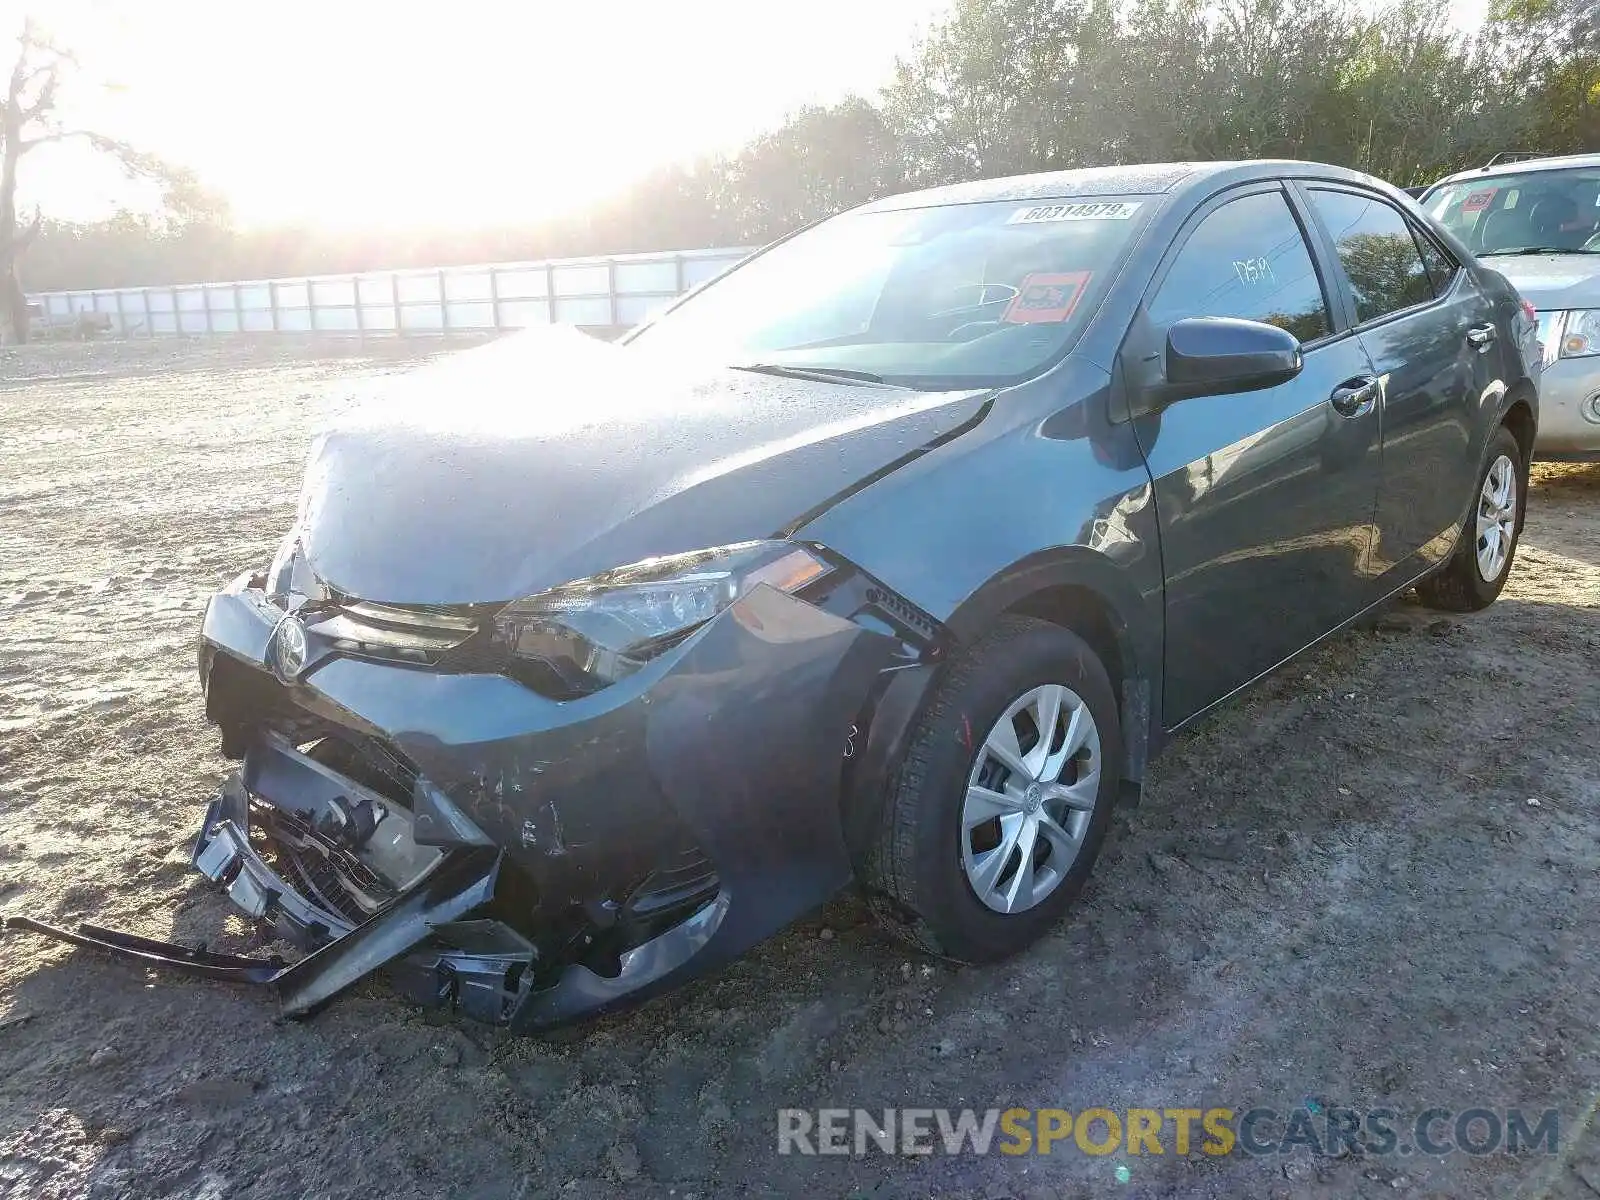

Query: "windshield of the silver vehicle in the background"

xmin=1422 ymin=166 xmax=1600 ymax=256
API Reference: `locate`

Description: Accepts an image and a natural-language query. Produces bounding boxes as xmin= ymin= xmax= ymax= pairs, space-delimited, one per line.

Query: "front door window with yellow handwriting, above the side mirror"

xmin=1149 ymin=192 xmax=1333 ymax=342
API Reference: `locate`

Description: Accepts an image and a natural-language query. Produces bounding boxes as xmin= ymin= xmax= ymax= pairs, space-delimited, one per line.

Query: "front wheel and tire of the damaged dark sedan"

xmin=862 ymin=616 xmax=1122 ymax=963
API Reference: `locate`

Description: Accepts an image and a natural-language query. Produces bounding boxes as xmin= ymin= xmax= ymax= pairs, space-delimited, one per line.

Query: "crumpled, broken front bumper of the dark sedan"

xmin=6 ymin=578 xmax=914 ymax=1030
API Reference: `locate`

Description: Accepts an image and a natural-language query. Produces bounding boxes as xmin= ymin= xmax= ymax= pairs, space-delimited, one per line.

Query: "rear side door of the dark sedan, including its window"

xmin=1306 ymin=184 xmax=1499 ymax=585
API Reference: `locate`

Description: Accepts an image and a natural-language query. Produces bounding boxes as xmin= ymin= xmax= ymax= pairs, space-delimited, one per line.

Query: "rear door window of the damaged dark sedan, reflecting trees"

xmin=1310 ymin=187 xmax=1434 ymax=322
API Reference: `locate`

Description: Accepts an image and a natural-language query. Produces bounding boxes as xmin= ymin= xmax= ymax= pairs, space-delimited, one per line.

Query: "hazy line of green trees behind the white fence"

xmin=18 ymin=0 xmax=1600 ymax=290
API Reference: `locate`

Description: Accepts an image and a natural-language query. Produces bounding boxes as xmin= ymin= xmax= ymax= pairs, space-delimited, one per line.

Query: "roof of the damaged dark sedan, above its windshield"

xmin=854 ymin=158 xmax=1379 ymax=213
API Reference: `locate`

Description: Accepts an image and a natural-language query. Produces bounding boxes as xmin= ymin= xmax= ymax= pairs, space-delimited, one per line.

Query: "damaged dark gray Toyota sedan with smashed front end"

xmin=19 ymin=163 xmax=1539 ymax=1030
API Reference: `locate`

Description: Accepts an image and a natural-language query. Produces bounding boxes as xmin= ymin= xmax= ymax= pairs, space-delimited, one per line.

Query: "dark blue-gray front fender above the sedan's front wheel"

xmin=795 ymin=355 xmax=1163 ymax=809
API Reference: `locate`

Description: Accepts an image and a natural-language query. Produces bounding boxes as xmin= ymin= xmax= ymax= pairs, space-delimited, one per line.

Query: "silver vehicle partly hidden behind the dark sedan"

xmin=1418 ymin=154 xmax=1600 ymax=462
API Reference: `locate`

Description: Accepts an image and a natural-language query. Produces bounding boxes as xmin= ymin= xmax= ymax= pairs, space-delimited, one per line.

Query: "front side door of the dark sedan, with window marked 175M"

xmin=1125 ymin=184 xmax=1381 ymax=728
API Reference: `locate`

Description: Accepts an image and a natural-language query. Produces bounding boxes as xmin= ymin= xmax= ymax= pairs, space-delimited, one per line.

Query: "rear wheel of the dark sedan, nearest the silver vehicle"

xmin=1416 ymin=426 xmax=1528 ymax=613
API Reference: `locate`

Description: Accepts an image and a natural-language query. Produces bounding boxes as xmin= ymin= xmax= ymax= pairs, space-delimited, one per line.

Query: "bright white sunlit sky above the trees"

xmin=15 ymin=0 xmax=1486 ymax=229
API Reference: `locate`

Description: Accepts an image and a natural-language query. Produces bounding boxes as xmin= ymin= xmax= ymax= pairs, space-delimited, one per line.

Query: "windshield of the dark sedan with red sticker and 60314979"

xmin=632 ymin=197 xmax=1150 ymax=387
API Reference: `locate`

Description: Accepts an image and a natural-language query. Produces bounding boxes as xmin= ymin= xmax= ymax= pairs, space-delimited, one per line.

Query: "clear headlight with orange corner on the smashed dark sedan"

xmin=494 ymin=541 xmax=832 ymax=693
